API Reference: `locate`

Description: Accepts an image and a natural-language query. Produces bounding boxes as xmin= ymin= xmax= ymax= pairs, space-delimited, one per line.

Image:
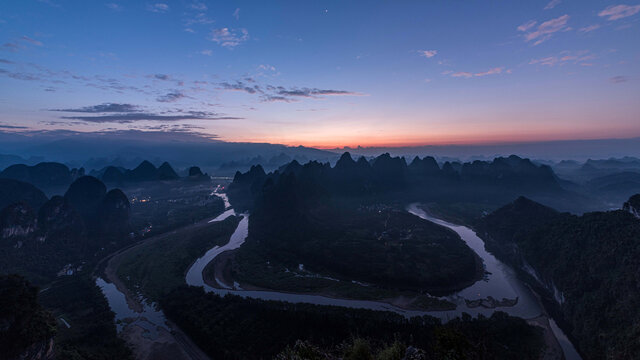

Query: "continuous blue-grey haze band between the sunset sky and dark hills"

xmin=0 ymin=130 xmax=640 ymax=175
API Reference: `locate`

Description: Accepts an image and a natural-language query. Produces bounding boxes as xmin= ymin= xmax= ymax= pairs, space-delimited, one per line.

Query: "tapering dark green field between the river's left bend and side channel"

xmin=117 ymin=216 xmax=240 ymax=300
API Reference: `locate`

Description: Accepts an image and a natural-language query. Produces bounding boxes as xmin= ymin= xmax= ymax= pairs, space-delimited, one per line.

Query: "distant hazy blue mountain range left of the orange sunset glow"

xmin=0 ymin=130 xmax=335 ymax=172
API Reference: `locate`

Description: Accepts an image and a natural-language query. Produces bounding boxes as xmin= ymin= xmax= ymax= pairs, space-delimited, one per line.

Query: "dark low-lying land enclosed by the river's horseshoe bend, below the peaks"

xmin=245 ymin=191 xmax=478 ymax=293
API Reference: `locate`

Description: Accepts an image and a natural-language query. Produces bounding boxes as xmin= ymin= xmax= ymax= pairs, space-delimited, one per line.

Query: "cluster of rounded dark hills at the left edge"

xmin=0 ymin=176 xmax=131 ymax=285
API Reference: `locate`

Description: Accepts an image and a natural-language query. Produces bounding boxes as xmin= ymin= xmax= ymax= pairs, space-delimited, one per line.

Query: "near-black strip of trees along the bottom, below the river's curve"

xmin=160 ymin=286 xmax=544 ymax=359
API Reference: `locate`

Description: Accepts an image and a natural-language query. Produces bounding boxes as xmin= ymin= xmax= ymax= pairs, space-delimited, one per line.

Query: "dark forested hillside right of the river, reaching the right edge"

xmin=476 ymin=195 xmax=640 ymax=359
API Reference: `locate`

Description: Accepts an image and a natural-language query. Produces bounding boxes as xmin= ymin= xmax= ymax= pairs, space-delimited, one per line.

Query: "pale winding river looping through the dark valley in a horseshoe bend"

xmin=97 ymin=193 xmax=581 ymax=360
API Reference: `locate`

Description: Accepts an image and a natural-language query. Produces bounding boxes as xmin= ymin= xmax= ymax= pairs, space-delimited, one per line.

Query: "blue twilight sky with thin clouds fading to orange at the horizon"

xmin=0 ymin=0 xmax=640 ymax=148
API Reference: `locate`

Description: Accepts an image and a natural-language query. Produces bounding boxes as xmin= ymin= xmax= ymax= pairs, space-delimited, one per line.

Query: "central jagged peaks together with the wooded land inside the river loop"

xmin=228 ymin=153 xmax=566 ymax=293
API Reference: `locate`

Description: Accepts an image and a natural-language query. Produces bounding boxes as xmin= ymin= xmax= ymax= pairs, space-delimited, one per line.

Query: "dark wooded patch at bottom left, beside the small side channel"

xmin=40 ymin=274 xmax=131 ymax=360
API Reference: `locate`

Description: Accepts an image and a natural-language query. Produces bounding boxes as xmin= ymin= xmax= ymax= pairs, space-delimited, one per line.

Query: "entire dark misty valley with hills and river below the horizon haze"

xmin=0 ymin=153 xmax=640 ymax=359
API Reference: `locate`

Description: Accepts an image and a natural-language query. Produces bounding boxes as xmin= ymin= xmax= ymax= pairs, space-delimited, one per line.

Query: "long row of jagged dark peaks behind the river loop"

xmin=228 ymin=152 xmax=579 ymax=214
